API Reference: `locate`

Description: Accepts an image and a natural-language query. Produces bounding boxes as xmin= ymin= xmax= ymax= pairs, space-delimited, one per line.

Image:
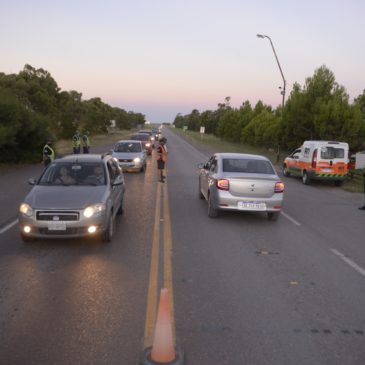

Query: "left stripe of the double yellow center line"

xmin=143 ymin=184 xmax=161 ymax=348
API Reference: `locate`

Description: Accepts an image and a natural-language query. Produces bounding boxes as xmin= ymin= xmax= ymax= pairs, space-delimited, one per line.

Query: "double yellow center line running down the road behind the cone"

xmin=143 ymin=178 xmax=176 ymax=348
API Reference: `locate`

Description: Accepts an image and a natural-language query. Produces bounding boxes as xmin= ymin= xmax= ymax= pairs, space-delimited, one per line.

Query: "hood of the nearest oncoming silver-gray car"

xmin=25 ymin=185 xmax=106 ymax=209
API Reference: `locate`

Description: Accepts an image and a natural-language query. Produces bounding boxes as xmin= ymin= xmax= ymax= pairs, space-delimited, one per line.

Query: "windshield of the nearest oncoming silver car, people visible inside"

xmin=38 ymin=163 xmax=106 ymax=186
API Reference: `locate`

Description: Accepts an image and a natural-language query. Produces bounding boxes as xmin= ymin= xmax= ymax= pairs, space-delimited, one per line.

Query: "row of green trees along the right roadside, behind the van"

xmin=174 ymin=66 xmax=365 ymax=150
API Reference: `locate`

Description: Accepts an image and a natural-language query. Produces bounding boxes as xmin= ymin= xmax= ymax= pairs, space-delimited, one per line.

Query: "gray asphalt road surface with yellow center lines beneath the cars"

xmin=0 ymin=130 xmax=365 ymax=365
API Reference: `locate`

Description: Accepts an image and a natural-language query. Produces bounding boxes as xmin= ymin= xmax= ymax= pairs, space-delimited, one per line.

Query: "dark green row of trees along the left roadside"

xmin=0 ymin=65 xmax=146 ymax=162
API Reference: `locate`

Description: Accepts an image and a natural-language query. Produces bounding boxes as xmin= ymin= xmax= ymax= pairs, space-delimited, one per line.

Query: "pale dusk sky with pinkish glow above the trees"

xmin=0 ymin=0 xmax=365 ymax=123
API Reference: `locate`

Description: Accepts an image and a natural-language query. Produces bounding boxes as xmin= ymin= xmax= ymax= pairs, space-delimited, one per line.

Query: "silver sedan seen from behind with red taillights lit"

xmin=198 ymin=153 xmax=284 ymax=220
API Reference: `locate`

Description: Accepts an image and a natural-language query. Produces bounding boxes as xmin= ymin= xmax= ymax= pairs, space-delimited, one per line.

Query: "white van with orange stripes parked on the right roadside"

xmin=283 ymin=141 xmax=349 ymax=185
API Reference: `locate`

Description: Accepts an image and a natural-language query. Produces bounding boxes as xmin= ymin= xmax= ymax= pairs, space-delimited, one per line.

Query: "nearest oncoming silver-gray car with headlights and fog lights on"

xmin=19 ymin=154 xmax=125 ymax=242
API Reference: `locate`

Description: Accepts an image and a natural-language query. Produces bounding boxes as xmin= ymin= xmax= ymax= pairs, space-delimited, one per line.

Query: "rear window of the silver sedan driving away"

xmin=223 ymin=158 xmax=275 ymax=175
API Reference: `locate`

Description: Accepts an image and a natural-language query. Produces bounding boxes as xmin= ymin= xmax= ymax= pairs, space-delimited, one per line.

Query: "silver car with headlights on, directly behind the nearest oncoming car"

xmin=112 ymin=140 xmax=147 ymax=172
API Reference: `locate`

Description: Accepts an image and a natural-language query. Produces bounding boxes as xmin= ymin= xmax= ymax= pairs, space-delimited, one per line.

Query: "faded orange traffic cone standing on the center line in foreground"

xmin=151 ymin=289 xmax=175 ymax=363
